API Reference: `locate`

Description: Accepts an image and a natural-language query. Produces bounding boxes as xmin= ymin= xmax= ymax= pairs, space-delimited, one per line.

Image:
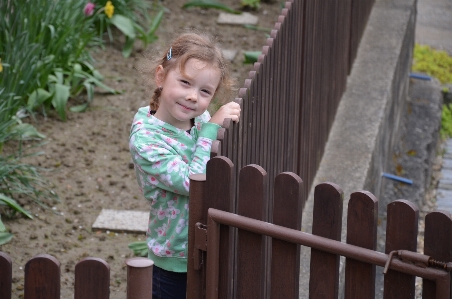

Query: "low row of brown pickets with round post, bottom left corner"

xmin=0 ymin=251 xmax=153 ymax=299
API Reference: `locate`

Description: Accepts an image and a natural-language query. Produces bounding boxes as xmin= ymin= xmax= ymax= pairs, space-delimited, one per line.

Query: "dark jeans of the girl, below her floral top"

xmin=152 ymin=265 xmax=187 ymax=299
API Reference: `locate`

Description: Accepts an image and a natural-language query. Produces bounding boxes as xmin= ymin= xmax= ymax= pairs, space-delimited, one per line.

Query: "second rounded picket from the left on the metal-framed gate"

xmin=236 ymin=165 xmax=268 ymax=298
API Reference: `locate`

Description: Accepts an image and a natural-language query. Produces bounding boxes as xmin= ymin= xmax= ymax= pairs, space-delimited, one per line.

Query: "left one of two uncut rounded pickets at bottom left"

xmin=24 ymin=254 xmax=60 ymax=299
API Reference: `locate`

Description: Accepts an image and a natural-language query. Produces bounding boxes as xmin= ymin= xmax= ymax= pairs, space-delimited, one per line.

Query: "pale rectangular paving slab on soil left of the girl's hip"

xmin=92 ymin=209 xmax=149 ymax=232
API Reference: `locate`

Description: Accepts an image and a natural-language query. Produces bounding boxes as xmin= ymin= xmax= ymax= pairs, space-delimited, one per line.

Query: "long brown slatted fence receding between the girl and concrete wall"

xmin=219 ymin=0 xmax=374 ymax=210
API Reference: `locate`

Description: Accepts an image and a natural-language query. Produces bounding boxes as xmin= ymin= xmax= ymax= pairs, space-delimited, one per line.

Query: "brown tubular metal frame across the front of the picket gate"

xmin=206 ymin=209 xmax=451 ymax=299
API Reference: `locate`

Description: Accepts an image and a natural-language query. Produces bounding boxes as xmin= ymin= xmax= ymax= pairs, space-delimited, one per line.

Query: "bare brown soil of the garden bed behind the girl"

xmin=0 ymin=0 xmax=281 ymax=298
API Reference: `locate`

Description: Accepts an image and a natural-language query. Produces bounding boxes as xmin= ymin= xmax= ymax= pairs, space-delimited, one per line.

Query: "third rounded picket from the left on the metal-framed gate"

xmin=270 ymin=172 xmax=304 ymax=299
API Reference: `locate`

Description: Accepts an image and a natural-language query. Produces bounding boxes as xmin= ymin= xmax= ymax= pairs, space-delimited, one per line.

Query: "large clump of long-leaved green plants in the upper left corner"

xmin=0 ymin=0 xmax=116 ymax=120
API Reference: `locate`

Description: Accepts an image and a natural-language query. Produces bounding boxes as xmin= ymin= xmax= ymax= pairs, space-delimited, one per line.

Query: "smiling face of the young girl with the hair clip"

xmin=155 ymin=58 xmax=221 ymax=130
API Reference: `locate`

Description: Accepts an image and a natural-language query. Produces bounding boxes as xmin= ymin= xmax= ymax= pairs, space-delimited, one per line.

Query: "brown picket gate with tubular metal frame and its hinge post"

xmin=187 ymin=157 xmax=452 ymax=299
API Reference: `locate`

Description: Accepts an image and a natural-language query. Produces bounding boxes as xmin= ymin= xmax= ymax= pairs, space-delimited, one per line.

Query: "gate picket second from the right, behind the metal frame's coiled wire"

xmin=383 ymin=199 xmax=419 ymax=299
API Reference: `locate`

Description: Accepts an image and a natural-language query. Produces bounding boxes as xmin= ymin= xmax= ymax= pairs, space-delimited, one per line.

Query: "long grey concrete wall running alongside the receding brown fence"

xmin=300 ymin=0 xmax=416 ymax=298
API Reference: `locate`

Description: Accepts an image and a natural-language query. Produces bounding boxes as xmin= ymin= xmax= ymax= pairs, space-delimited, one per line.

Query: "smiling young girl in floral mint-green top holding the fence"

xmin=129 ymin=33 xmax=240 ymax=299
